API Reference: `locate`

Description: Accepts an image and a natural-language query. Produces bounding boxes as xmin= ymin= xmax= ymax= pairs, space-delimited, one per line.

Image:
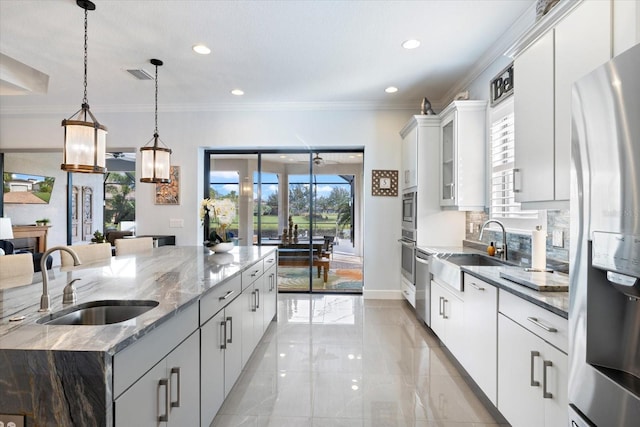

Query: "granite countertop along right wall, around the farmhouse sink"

xmin=417 ymin=246 xmax=569 ymax=319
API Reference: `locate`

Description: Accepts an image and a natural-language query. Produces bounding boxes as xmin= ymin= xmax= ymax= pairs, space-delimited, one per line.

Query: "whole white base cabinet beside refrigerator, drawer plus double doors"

xmin=497 ymin=291 xmax=569 ymax=427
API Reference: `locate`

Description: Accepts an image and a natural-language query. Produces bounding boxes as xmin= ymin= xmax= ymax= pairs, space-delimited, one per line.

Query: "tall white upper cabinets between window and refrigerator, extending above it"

xmin=514 ymin=1 xmax=612 ymax=208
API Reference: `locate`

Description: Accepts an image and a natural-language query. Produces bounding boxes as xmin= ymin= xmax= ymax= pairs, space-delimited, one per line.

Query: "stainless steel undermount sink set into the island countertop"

xmin=37 ymin=300 xmax=159 ymax=325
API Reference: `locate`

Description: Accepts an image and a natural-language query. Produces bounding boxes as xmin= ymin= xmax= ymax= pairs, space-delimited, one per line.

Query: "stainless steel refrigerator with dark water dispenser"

xmin=569 ymin=45 xmax=640 ymax=427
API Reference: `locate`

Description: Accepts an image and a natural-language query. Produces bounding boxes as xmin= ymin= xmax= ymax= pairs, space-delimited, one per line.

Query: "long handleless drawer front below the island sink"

xmin=113 ymin=304 xmax=198 ymax=399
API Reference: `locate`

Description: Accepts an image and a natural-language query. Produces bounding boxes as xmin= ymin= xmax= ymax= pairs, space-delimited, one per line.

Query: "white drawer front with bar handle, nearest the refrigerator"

xmin=498 ymin=290 xmax=569 ymax=353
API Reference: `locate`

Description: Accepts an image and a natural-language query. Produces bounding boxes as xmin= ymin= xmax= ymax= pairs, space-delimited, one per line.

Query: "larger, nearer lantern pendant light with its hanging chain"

xmin=60 ymin=0 xmax=107 ymax=174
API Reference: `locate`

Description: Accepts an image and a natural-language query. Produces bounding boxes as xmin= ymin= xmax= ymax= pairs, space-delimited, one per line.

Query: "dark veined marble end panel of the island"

xmin=0 ymin=350 xmax=113 ymax=427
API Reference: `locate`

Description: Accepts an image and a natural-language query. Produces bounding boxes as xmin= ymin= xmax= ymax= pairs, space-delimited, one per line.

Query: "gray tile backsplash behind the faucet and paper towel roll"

xmin=465 ymin=210 xmax=569 ymax=273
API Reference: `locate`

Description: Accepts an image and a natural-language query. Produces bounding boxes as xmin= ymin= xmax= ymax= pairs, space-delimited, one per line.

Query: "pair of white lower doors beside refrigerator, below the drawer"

xmin=498 ymin=313 xmax=569 ymax=427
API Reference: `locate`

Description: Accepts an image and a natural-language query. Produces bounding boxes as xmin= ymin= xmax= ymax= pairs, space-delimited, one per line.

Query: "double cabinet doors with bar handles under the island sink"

xmin=115 ymin=332 xmax=200 ymax=427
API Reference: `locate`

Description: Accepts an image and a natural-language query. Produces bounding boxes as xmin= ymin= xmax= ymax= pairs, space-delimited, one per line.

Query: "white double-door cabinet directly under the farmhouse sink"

xmin=431 ymin=280 xmax=466 ymax=365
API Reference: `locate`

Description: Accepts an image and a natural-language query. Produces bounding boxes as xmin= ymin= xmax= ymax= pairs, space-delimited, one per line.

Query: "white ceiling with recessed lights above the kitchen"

xmin=0 ymin=0 xmax=535 ymax=115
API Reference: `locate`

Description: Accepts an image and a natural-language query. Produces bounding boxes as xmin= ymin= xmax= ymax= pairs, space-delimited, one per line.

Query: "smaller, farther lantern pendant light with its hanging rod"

xmin=140 ymin=59 xmax=171 ymax=184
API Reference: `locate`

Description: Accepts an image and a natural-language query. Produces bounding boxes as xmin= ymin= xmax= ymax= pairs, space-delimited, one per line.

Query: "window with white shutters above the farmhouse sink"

xmin=490 ymin=99 xmax=539 ymax=228
